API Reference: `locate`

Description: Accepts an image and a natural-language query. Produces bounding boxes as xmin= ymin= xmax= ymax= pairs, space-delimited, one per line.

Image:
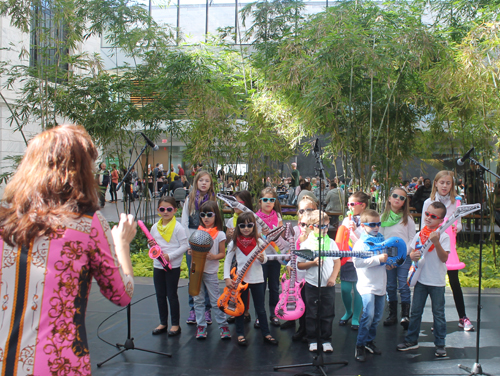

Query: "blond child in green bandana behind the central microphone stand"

xmin=297 ymin=210 xmax=340 ymax=352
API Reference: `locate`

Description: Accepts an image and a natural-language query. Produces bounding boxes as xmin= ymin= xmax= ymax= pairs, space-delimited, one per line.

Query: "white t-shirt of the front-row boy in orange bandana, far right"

xmin=411 ymin=232 xmax=450 ymax=287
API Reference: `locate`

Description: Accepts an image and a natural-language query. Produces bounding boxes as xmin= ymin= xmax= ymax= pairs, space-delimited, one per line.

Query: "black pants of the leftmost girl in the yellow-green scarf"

xmin=153 ymin=268 xmax=181 ymax=326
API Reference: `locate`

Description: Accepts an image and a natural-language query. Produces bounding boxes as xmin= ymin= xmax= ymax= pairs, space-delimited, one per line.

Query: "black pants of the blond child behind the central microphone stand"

xmin=304 ymin=283 xmax=335 ymax=345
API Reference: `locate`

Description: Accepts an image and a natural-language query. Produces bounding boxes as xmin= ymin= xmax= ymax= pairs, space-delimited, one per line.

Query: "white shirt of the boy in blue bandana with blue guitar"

xmin=352 ymin=240 xmax=387 ymax=296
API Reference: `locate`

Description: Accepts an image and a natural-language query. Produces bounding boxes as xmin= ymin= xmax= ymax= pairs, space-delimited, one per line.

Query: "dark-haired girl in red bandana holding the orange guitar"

xmin=225 ymin=213 xmax=278 ymax=346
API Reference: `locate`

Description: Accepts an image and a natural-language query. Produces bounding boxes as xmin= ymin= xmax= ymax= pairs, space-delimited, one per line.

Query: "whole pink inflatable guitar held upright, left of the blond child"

xmin=274 ymin=223 xmax=306 ymax=321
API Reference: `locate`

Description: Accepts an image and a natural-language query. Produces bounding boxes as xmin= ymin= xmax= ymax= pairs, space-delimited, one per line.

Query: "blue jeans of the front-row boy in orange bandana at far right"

xmin=405 ymin=282 xmax=446 ymax=346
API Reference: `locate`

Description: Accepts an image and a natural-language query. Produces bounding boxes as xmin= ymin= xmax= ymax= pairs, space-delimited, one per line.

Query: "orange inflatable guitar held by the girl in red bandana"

xmin=217 ymin=226 xmax=285 ymax=317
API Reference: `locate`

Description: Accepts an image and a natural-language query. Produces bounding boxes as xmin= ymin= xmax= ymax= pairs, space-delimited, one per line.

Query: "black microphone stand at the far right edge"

xmin=458 ymin=154 xmax=500 ymax=376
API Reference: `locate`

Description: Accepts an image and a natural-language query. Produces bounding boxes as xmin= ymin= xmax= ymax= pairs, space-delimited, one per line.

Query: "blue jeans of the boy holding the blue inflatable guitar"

xmin=356 ymin=294 xmax=385 ymax=346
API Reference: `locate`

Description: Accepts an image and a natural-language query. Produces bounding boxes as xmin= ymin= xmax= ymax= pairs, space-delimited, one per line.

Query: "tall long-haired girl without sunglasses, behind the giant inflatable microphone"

xmin=181 ymin=171 xmax=215 ymax=325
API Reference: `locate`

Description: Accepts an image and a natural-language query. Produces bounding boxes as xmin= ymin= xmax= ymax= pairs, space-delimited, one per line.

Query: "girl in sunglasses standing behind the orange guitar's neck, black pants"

xmin=254 ymin=187 xmax=289 ymax=328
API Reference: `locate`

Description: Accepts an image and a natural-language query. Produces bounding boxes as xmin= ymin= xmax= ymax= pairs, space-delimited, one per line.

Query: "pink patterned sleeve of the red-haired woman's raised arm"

xmin=88 ymin=212 xmax=134 ymax=307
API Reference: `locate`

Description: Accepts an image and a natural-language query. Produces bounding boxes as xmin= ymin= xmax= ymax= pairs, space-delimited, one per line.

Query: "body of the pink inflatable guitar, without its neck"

xmin=274 ymin=273 xmax=306 ymax=321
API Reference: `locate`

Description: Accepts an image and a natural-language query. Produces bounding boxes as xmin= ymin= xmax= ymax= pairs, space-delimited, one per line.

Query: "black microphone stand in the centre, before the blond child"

xmin=274 ymin=138 xmax=349 ymax=376
